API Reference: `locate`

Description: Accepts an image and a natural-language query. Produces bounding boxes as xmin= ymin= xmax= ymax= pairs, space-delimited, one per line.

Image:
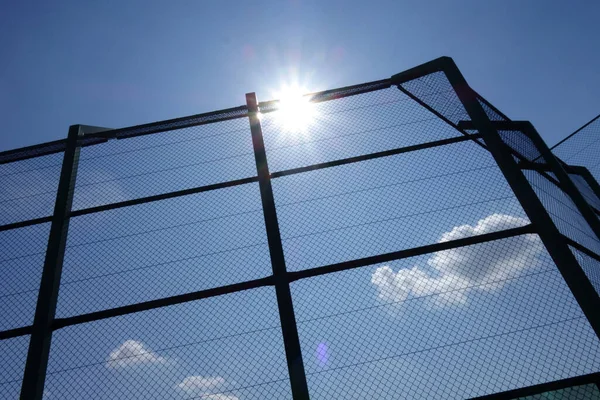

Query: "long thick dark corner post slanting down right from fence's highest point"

xmin=442 ymin=58 xmax=600 ymax=338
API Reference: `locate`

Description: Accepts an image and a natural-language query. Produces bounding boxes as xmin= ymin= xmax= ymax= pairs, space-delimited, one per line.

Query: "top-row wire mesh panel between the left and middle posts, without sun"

xmin=73 ymin=115 xmax=256 ymax=209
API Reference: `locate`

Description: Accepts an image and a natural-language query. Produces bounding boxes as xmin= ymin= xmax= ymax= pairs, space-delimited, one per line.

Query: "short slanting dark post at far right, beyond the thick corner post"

xmin=522 ymin=122 xmax=600 ymax=241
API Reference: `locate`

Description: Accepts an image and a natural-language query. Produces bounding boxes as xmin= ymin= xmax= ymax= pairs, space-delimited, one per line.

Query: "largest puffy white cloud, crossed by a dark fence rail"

xmin=371 ymin=214 xmax=543 ymax=307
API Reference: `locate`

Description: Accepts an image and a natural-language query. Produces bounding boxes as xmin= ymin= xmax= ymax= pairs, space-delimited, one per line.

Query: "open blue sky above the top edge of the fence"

xmin=0 ymin=0 xmax=600 ymax=150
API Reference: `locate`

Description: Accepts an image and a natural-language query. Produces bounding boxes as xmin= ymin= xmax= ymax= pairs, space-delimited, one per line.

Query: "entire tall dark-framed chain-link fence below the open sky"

xmin=0 ymin=58 xmax=600 ymax=400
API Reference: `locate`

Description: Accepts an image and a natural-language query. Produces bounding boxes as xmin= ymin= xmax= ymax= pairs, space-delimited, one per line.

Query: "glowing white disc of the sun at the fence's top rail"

xmin=275 ymin=86 xmax=316 ymax=133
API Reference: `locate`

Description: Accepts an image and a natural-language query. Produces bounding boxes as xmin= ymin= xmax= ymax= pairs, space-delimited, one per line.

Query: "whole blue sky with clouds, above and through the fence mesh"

xmin=0 ymin=1 xmax=600 ymax=400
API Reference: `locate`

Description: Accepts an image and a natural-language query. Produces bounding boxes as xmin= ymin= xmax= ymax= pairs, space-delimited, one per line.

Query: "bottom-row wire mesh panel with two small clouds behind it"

xmin=46 ymin=288 xmax=290 ymax=400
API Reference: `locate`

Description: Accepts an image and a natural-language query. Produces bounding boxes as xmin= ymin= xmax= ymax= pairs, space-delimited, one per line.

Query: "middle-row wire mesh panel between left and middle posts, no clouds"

xmin=57 ymin=183 xmax=271 ymax=317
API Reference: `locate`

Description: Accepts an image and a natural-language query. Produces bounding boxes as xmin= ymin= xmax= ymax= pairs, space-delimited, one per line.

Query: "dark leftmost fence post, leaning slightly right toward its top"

xmin=21 ymin=125 xmax=83 ymax=400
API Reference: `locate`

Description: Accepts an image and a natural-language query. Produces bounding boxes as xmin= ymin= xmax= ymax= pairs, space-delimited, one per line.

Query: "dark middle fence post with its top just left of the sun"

xmin=246 ymin=93 xmax=309 ymax=400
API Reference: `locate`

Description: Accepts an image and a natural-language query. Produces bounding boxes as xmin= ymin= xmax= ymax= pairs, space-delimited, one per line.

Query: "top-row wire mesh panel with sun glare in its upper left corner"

xmin=261 ymin=87 xmax=460 ymax=172
